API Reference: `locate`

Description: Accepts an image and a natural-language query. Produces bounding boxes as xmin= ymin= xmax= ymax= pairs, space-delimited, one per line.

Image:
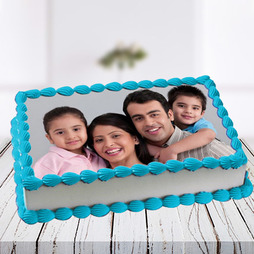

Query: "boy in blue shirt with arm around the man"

xmin=150 ymin=85 xmax=216 ymax=163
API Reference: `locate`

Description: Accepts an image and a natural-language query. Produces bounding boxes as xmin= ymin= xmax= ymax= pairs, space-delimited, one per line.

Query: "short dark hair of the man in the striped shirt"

xmin=123 ymin=89 xmax=169 ymax=117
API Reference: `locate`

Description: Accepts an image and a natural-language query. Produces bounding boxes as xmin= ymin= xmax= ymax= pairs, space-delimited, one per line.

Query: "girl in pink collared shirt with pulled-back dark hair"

xmin=34 ymin=106 xmax=106 ymax=179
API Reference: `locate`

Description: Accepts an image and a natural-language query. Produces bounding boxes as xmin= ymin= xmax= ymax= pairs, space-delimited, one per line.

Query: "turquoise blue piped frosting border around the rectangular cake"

xmin=11 ymin=76 xmax=253 ymax=224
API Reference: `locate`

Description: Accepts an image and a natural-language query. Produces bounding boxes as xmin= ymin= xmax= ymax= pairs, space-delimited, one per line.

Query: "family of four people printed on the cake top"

xmin=33 ymin=85 xmax=234 ymax=179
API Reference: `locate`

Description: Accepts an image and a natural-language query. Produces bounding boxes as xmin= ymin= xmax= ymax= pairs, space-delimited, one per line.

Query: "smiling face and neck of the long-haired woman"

xmin=93 ymin=125 xmax=140 ymax=168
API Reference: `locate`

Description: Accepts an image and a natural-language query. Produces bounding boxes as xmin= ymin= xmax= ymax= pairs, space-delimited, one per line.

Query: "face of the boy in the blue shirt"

xmin=172 ymin=95 xmax=205 ymax=130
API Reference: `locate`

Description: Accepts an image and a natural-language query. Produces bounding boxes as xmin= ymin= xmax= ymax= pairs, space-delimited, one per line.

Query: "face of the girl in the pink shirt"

xmin=46 ymin=114 xmax=87 ymax=154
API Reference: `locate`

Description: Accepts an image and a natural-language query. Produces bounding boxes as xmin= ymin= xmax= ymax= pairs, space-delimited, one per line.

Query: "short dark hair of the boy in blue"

xmin=168 ymin=85 xmax=206 ymax=111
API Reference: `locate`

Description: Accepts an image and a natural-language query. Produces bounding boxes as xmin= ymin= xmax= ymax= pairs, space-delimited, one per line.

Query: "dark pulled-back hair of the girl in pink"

xmin=43 ymin=106 xmax=87 ymax=134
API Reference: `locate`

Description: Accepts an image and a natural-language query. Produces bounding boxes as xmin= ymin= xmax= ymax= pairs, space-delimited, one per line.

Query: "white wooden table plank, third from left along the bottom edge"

xmin=75 ymin=213 xmax=113 ymax=254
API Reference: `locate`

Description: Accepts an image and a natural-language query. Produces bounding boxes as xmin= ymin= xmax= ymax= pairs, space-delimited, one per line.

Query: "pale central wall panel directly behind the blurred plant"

xmin=50 ymin=0 xmax=198 ymax=84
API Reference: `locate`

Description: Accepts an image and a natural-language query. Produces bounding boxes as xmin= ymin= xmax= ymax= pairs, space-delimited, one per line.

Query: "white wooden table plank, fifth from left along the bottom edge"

xmin=147 ymin=207 xmax=184 ymax=254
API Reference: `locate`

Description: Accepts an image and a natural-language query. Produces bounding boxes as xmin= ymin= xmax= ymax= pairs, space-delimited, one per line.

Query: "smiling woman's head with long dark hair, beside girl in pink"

xmin=88 ymin=113 xmax=152 ymax=168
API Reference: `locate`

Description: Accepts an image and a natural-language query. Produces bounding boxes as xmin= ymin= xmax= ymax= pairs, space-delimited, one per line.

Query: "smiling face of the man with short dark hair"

xmin=127 ymin=100 xmax=174 ymax=146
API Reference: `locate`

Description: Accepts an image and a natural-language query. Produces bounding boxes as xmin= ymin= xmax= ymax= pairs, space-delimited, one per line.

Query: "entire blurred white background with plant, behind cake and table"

xmin=0 ymin=0 xmax=254 ymax=148
